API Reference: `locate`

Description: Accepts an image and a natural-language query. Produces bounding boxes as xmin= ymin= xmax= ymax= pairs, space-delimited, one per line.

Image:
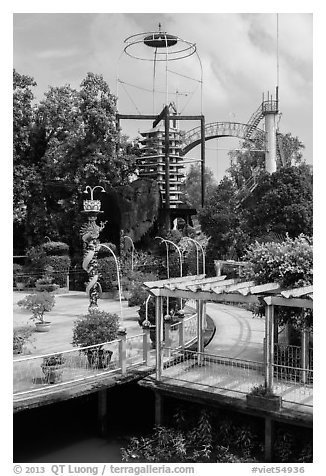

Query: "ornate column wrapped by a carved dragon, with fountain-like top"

xmin=80 ymin=185 xmax=106 ymax=312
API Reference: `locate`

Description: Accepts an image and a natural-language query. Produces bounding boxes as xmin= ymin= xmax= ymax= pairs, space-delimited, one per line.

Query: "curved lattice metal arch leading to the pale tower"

xmin=180 ymin=122 xmax=266 ymax=156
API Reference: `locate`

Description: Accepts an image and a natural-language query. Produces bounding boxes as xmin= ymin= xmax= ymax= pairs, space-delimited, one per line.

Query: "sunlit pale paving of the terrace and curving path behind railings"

xmin=13 ymin=292 xmax=265 ymax=362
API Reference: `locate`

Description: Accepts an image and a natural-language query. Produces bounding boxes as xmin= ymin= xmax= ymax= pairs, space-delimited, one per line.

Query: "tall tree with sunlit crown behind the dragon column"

xmin=13 ymin=73 xmax=135 ymax=250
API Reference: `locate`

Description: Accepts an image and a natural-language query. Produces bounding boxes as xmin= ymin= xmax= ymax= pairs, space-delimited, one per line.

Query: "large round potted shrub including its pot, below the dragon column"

xmin=72 ymin=309 xmax=119 ymax=369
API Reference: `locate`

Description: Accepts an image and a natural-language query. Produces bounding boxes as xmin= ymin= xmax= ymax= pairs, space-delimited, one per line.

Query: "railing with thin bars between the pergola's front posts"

xmin=162 ymin=348 xmax=313 ymax=408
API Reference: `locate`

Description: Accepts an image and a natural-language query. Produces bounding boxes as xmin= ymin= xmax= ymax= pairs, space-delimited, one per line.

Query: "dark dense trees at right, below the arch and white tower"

xmin=199 ymin=164 xmax=313 ymax=261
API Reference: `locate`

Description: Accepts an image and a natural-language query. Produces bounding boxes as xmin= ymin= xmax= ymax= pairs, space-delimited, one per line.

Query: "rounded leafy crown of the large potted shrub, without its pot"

xmin=72 ymin=309 xmax=119 ymax=347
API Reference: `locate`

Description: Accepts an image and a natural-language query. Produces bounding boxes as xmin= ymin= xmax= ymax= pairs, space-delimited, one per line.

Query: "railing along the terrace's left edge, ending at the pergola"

xmin=13 ymin=332 xmax=154 ymax=398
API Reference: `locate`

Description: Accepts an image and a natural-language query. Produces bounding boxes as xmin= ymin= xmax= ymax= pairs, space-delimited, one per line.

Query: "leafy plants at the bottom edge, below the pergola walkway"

xmin=121 ymin=404 xmax=312 ymax=463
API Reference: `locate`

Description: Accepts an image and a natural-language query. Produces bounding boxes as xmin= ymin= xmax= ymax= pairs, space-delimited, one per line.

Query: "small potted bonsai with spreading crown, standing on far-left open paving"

xmin=17 ymin=291 xmax=55 ymax=332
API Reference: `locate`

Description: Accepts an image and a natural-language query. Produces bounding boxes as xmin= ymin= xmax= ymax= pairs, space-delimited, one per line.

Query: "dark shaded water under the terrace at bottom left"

xmin=13 ymin=384 xmax=154 ymax=463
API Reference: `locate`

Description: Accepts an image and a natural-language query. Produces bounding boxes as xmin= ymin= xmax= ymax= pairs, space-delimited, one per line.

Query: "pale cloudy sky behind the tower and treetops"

xmin=13 ymin=13 xmax=313 ymax=182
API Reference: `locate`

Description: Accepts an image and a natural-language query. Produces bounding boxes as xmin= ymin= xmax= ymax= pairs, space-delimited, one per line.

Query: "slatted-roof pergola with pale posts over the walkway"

xmin=144 ymin=275 xmax=313 ymax=390
